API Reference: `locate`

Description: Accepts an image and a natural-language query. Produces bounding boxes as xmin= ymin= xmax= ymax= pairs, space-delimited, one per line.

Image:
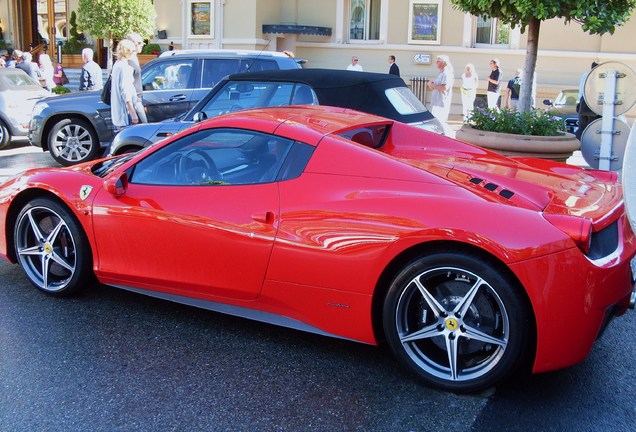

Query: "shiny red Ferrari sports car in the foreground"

xmin=0 ymin=106 xmax=636 ymax=392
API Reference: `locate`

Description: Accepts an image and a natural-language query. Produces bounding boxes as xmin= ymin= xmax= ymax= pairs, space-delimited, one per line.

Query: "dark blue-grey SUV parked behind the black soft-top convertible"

xmin=29 ymin=50 xmax=300 ymax=166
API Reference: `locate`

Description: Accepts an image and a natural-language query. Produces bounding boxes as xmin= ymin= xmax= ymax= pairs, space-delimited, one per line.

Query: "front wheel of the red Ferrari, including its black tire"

xmin=14 ymin=198 xmax=93 ymax=296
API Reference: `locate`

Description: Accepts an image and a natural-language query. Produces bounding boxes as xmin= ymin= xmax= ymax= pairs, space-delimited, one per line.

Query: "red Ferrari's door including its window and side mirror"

xmin=93 ymin=129 xmax=292 ymax=300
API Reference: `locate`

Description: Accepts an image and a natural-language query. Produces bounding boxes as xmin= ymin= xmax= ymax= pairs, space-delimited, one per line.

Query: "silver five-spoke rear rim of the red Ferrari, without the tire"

xmin=395 ymin=267 xmax=510 ymax=382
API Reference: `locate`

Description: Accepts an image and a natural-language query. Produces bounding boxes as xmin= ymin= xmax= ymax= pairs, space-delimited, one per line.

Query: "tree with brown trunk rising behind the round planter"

xmin=450 ymin=0 xmax=636 ymax=111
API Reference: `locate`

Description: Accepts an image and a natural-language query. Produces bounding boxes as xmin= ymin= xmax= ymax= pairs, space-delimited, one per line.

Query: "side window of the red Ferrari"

xmin=130 ymin=129 xmax=304 ymax=186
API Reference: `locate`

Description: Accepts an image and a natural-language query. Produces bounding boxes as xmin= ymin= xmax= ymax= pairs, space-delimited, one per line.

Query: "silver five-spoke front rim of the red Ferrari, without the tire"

xmin=15 ymin=206 xmax=77 ymax=293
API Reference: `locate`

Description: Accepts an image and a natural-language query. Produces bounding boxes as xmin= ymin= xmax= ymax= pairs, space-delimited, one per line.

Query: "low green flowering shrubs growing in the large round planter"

xmin=468 ymin=108 xmax=565 ymax=136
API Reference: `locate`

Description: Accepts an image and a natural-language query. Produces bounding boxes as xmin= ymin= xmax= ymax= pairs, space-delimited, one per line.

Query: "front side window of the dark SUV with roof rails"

xmin=141 ymin=59 xmax=194 ymax=90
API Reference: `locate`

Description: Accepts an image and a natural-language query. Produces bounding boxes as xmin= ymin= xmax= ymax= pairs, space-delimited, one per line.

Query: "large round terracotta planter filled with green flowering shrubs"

xmin=456 ymin=108 xmax=580 ymax=162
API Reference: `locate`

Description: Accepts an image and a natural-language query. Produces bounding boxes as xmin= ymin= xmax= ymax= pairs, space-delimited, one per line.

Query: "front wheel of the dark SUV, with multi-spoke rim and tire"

xmin=47 ymin=118 xmax=100 ymax=166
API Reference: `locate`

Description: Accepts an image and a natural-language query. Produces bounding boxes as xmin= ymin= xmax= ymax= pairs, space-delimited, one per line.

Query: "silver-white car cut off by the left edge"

xmin=0 ymin=68 xmax=51 ymax=149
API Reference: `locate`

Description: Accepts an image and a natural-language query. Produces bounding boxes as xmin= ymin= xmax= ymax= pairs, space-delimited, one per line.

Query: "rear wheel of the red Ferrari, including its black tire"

xmin=383 ymin=251 xmax=532 ymax=393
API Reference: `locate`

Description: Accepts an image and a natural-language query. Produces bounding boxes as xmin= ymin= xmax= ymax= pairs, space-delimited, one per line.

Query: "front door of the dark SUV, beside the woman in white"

xmin=141 ymin=57 xmax=200 ymax=122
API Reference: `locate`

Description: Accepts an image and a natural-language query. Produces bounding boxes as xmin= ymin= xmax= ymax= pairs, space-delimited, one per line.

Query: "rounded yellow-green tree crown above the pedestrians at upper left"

xmin=77 ymin=0 xmax=157 ymax=40
